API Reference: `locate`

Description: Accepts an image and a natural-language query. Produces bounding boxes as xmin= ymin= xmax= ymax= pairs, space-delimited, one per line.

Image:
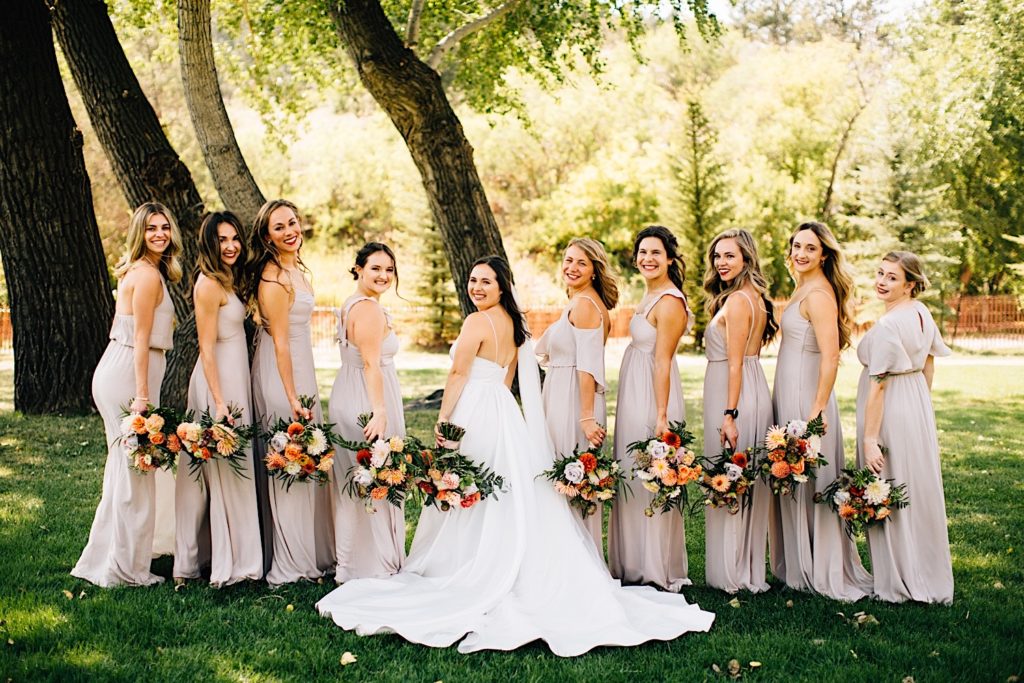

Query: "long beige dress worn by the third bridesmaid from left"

xmin=252 ymin=288 xmax=335 ymax=586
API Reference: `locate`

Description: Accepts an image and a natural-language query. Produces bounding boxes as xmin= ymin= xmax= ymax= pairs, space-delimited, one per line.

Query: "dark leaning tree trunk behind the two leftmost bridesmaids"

xmin=52 ymin=0 xmax=204 ymax=408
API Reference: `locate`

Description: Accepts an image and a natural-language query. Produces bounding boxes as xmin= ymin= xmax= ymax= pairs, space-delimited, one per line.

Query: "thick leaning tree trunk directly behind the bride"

xmin=331 ymin=0 xmax=505 ymax=313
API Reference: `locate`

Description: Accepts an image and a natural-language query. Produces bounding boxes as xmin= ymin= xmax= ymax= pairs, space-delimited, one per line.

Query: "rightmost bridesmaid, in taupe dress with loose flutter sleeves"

xmin=857 ymin=252 xmax=953 ymax=604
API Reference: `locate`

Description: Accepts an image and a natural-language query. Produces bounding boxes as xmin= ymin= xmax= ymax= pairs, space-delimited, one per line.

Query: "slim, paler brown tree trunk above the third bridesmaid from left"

xmin=178 ymin=0 xmax=265 ymax=225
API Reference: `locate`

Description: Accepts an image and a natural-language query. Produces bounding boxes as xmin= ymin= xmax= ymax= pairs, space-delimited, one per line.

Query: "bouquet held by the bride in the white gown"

xmin=415 ymin=422 xmax=505 ymax=512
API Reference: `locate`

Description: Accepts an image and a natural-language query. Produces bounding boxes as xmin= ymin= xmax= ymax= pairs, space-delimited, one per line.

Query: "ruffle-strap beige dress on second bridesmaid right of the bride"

xmin=608 ymin=288 xmax=693 ymax=593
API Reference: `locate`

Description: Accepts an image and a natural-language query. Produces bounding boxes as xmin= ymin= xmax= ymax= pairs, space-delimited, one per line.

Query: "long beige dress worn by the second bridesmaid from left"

xmin=174 ymin=293 xmax=263 ymax=587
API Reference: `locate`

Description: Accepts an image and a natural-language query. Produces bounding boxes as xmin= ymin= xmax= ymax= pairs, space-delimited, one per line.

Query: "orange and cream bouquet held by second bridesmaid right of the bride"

xmin=629 ymin=422 xmax=702 ymax=517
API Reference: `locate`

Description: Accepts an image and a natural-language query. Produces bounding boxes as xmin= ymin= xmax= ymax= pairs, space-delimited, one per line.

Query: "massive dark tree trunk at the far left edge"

xmin=0 ymin=0 xmax=114 ymax=413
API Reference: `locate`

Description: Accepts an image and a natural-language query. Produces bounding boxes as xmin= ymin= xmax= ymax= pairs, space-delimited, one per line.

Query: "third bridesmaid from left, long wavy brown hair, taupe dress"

xmin=247 ymin=200 xmax=334 ymax=586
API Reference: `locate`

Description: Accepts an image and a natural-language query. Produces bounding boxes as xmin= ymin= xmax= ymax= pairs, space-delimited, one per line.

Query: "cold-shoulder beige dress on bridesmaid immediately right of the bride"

xmin=537 ymin=296 xmax=608 ymax=556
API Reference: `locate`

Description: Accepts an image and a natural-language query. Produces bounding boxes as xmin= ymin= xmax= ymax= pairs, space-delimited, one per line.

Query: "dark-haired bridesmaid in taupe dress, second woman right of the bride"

xmin=608 ymin=225 xmax=693 ymax=593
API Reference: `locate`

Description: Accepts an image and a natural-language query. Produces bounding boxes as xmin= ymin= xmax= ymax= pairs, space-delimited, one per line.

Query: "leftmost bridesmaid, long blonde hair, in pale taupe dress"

xmin=71 ymin=202 xmax=181 ymax=587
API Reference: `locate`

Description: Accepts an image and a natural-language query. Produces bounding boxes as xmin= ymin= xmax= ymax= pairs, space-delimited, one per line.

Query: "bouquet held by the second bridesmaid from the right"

xmin=758 ymin=415 xmax=828 ymax=496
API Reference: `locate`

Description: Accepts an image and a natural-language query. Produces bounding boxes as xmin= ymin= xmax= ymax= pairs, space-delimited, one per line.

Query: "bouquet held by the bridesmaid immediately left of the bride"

xmin=339 ymin=413 xmax=425 ymax=514
